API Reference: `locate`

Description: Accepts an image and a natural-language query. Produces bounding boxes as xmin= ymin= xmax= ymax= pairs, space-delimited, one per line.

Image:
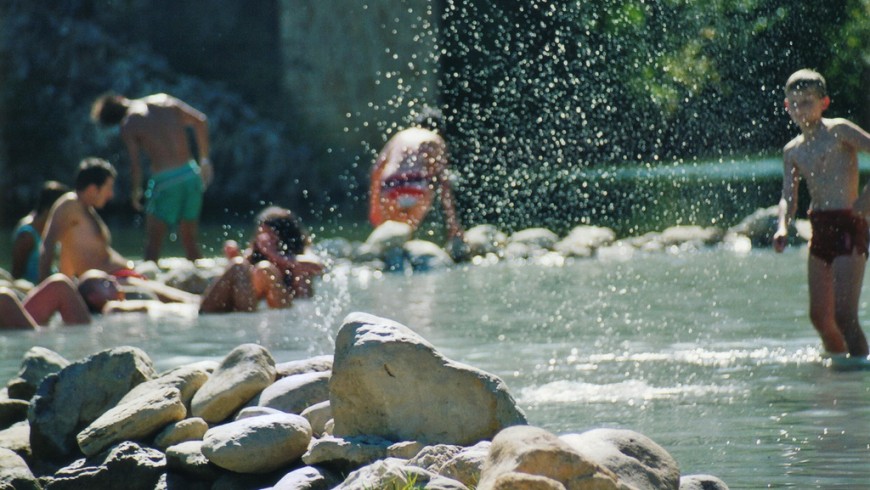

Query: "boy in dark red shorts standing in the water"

xmin=773 ymin=69 xmax=870 ymax=359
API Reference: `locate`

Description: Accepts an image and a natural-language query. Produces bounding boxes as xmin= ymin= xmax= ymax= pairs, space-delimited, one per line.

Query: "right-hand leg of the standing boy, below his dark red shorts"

xmin=831 ymin=253 xmax=868 ymax=357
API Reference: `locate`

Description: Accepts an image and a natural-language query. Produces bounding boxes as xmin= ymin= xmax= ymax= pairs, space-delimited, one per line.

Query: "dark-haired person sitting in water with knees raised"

xmin=200 ymin=206 xmax=323 ymax=313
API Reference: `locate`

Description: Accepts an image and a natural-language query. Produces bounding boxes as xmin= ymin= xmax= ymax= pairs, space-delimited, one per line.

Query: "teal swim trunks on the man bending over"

xmin=145 ymin=160 xmax=203 ymax=226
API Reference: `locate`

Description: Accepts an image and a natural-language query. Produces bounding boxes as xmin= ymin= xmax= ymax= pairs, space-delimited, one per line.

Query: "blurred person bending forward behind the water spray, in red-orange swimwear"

xmin=369 ymin=108 xmax=463 ymax=258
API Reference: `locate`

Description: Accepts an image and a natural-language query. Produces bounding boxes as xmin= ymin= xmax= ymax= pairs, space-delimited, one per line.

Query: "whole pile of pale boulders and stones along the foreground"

xmin=0 ymin=313 xmax=727 ymax=490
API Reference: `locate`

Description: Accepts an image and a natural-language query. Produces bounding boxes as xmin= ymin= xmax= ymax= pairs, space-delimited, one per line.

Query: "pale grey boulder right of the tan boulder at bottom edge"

xmin=560 ymin=429 xmax=680 ymax=490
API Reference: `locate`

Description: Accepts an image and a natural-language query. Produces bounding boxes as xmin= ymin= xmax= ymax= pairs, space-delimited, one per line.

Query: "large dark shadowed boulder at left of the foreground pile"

xmin=28 ymin=347 xmax=154 ymax=463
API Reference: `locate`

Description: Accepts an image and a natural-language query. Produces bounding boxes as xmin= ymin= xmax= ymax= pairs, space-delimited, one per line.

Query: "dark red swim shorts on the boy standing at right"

xmin=809 ymin=209 xmax=868 ymax=264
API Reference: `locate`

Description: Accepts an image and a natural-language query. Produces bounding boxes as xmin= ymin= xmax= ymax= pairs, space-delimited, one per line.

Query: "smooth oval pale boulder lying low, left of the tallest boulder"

xmin=202 ymin=413 xmax=311 ymax=473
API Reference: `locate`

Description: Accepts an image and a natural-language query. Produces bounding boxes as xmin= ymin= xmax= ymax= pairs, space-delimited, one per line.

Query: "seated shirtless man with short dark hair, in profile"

xmin=39 ymin=158 xmax=133 ymax=279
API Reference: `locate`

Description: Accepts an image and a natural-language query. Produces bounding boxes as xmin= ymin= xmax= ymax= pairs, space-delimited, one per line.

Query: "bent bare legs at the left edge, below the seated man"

xmin=0 ymin=274 xmax=91 ymax=329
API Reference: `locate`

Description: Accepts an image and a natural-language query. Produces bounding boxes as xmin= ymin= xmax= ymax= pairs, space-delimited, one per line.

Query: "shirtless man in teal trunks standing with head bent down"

xmin=91 ymin=90 xmax=212 ymax=261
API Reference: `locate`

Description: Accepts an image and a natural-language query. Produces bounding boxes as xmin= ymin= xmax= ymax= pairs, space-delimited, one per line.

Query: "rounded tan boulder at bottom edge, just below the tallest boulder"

xmin=477 ymin=425 xmax=628 ymax=490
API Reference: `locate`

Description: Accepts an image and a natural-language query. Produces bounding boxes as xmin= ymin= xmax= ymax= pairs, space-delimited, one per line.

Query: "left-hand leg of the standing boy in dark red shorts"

xmin=807 ymin=255 xmax=848 ymax=354
